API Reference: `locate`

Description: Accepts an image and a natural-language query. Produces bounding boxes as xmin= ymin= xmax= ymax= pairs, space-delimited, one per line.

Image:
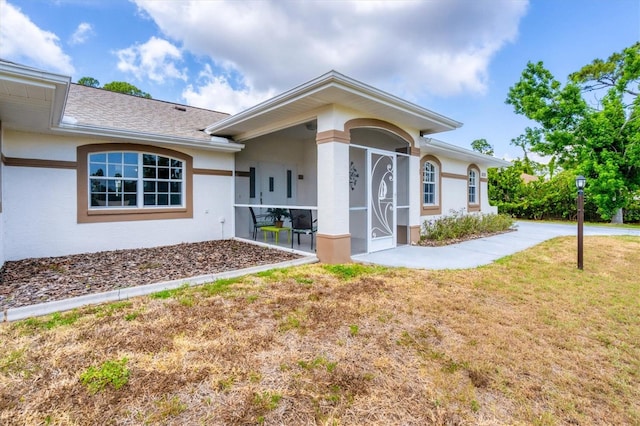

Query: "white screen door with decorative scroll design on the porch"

xmin=368 ymin=149 xmax=396 ymax=252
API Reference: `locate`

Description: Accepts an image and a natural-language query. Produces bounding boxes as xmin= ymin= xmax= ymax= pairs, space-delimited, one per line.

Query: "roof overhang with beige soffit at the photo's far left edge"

xmin=0 ymin=61 xmax=71 ymax=131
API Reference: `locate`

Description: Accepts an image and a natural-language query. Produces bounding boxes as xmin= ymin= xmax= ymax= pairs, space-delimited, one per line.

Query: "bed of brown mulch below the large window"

xmin=0 ymin=240 xmax=300 ymax=311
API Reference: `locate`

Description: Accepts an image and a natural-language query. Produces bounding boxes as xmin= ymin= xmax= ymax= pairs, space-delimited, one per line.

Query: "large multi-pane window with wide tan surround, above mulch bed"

xmin=78 ymin=144 xmax=193 ymax=223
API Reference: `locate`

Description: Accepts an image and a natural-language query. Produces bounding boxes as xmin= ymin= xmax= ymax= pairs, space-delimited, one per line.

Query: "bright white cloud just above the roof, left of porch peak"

xmin=182 ymin=65 xmax=275 ymax=114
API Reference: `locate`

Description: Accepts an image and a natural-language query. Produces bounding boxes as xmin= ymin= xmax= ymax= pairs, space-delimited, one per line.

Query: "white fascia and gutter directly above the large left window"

xmin=53 ymin=123 xmax=244 ymax=152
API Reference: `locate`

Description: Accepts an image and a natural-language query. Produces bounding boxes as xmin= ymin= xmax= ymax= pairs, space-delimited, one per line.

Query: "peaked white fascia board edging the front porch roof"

xmin=204 ymin=71 xmax=462 ymax=134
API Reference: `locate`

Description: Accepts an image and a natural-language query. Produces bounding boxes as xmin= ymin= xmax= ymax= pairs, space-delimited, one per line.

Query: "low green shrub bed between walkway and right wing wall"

xmin=422 ymin=209 xmax=514 ymax=241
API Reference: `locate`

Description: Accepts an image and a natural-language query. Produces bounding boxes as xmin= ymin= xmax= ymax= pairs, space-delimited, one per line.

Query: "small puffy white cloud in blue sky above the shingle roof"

xmin=115 ymin=37 xmax=187 ymax=83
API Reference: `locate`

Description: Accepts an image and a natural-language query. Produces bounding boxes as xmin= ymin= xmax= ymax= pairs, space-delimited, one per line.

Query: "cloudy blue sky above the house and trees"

xmin=0 ymin=0 xmax=640 ymax=159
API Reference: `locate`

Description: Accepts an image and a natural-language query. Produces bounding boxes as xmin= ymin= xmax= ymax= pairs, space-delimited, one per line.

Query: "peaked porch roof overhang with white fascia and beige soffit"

xmin=205 ymin=71 xmax=462 ymax=141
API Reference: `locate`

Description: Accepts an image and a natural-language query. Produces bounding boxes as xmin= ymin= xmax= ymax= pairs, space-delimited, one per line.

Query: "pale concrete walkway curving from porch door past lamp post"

xmin=352 ymin=222 xmax=640 ymax=269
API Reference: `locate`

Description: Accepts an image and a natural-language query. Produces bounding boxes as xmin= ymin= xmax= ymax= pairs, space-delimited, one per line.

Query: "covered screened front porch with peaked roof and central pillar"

xmin=206 ymin=71 xmax=460 ymax=263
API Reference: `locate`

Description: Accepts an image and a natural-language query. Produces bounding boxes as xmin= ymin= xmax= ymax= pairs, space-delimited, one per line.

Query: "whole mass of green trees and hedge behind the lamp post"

xmin=478 ymin=42 xmax=640 ymax=222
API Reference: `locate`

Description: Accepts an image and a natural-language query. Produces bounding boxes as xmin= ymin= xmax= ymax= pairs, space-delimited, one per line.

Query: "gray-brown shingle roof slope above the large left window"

xmin=64 ymin=84 xmax=229 ymax=141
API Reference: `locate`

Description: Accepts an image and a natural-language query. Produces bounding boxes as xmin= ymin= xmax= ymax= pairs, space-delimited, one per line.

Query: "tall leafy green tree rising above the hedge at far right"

xmin=506 ymin=43 xmax=640 ymax=220
